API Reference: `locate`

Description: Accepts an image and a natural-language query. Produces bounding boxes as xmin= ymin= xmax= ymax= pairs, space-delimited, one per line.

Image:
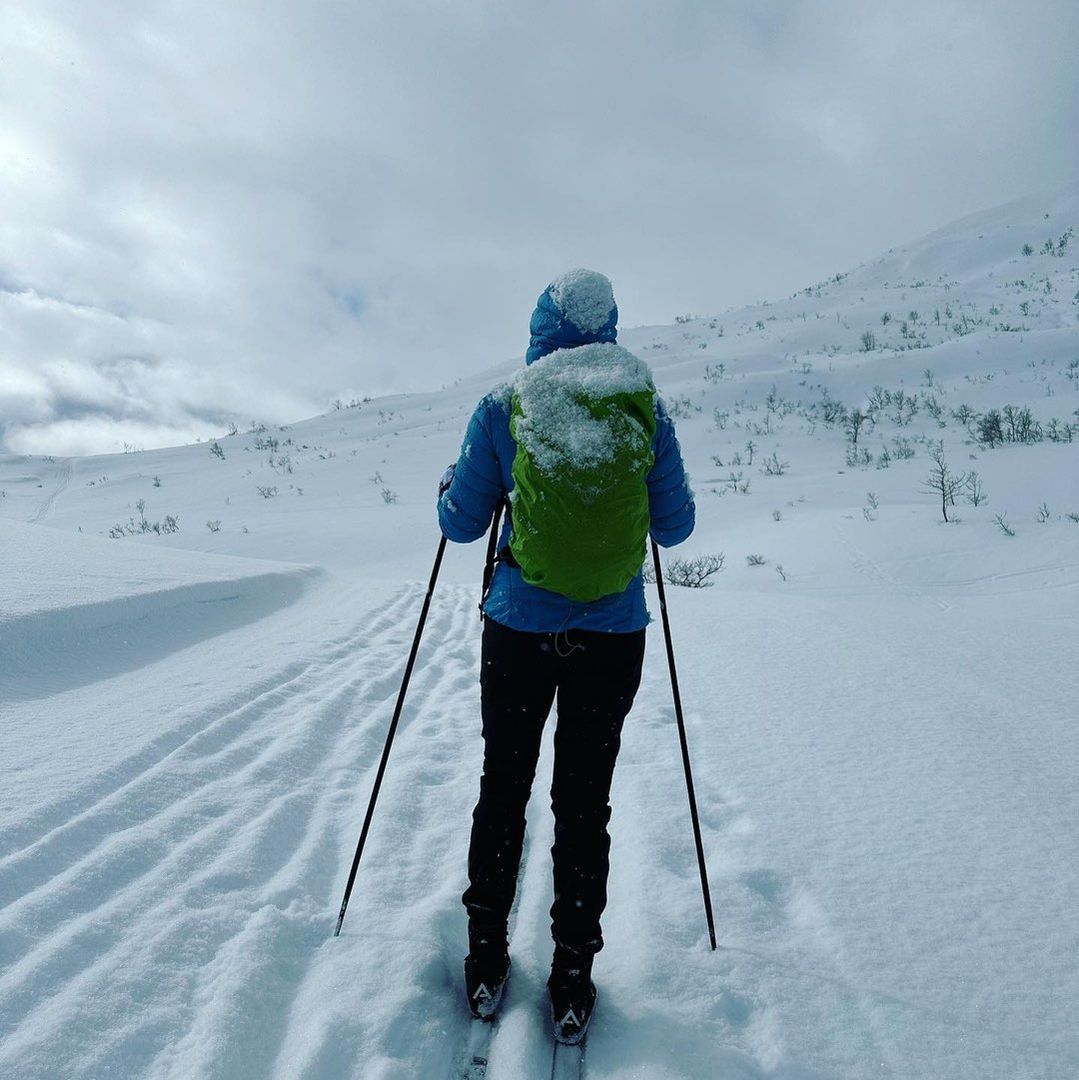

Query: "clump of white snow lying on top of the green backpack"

xmin=514 ymin=342 xmax=653 ymax=474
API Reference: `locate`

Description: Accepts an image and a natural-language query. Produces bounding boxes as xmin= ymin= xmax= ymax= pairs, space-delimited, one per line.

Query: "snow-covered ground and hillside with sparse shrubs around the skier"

xmin=0 ymin=186 xmax=1079 ymax=1080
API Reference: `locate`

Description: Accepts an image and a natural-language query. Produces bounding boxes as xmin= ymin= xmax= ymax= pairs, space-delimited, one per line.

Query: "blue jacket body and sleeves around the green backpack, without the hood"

xmin=439 ymin=388 xmax=696 ymax=633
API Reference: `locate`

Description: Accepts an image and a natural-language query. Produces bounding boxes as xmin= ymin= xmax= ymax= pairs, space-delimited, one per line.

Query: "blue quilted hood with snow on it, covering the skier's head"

xmin=525 ymin=270 xmax=618 ymax=364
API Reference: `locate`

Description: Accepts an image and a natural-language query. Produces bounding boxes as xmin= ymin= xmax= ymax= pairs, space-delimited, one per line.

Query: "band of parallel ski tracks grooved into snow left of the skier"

xmin=0 ymin=588 xmax=476 ymax=1077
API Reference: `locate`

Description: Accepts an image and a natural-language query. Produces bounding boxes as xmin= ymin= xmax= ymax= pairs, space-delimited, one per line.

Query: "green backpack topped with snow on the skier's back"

xmin=510 ymin=342 xmax=656 ymax=600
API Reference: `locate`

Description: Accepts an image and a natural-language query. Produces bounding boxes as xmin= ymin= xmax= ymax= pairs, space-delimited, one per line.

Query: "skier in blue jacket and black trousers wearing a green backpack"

xmin=437 ymin=270 xmax=694 ymax=1043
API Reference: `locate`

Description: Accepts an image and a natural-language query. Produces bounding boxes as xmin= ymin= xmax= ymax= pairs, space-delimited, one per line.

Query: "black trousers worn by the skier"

xmin=463 ymin=619 xmax=645 ymax=954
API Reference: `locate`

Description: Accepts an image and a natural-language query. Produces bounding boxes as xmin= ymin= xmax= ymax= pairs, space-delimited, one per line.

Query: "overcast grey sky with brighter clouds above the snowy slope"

xmin=0 ymin=0 xmax=1079 ymax=454
